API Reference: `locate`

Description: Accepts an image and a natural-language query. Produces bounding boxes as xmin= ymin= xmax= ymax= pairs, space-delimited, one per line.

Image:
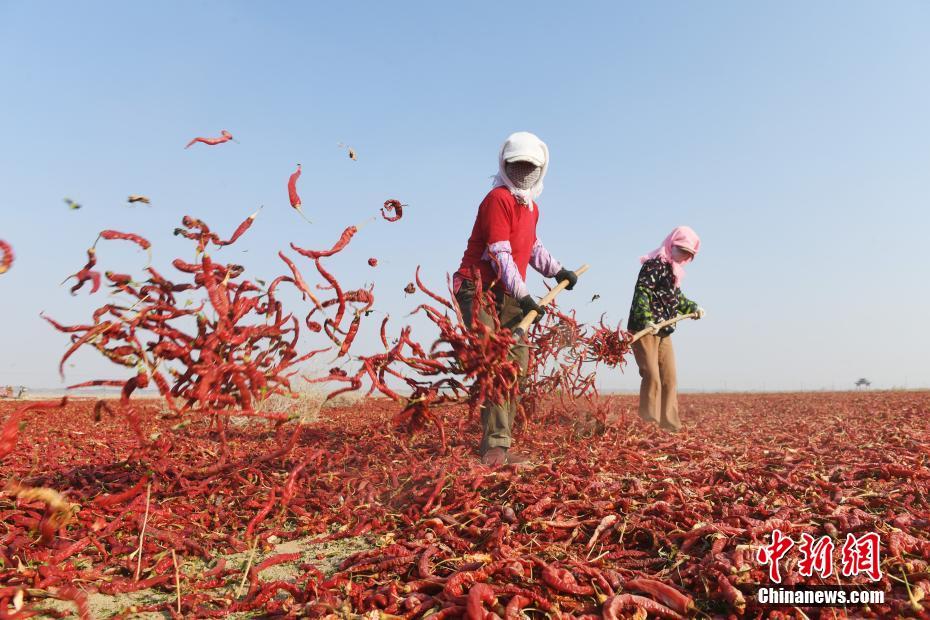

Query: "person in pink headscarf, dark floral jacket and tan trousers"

xmin=627 ymin=226 xmax=704 ymax=432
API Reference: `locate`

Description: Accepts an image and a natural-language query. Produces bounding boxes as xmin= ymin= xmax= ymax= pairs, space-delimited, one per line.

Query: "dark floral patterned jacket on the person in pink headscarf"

xmin=627 ymin=258 xmax=698 ymax=336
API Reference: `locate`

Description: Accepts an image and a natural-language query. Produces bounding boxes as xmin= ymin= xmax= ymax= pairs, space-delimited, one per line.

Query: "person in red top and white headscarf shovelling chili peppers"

xmin=452 ymin=131 xmax=578 ymax=466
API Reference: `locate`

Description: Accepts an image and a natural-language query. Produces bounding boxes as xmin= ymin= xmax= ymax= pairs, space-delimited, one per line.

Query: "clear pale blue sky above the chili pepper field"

xmin=0 ymin=1 xmax=930 ymax=390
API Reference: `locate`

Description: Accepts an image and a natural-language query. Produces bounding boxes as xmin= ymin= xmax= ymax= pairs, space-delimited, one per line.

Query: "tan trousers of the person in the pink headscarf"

xmin=633 ymin=334 xmax=681 ymax=431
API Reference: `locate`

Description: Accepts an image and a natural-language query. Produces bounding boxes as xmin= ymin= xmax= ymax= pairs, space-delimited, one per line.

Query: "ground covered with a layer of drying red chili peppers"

xmin=0 ymin=392 xmax=930 ymax=618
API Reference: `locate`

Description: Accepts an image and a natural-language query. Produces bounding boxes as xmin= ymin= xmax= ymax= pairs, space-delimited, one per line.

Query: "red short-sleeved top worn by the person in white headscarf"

xmin=455 ymin=187 xmax=539 ymax=286
